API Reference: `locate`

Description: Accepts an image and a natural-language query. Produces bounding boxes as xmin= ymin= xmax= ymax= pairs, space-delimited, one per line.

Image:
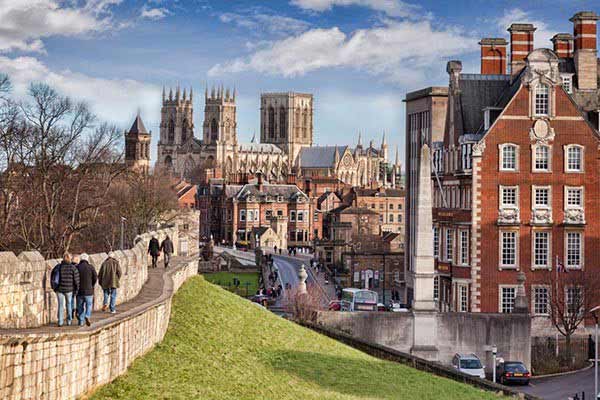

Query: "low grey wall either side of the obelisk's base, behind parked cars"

xmin=316 ymin=311 xmax=531 ymax=369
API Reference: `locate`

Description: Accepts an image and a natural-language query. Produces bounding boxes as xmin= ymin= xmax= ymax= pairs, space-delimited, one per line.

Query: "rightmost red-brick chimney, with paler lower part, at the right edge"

xmin=570 ymin=11 xmax=598 ymax=90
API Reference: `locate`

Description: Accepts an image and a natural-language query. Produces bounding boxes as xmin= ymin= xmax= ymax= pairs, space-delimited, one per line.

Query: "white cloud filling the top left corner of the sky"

xmin=0 ymin=0 xmax=122 ymax=53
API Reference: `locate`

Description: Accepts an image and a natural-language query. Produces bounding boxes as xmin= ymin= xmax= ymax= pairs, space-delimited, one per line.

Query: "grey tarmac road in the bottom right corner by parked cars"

xmin=515 ymin=368 xmax=594 ymax=400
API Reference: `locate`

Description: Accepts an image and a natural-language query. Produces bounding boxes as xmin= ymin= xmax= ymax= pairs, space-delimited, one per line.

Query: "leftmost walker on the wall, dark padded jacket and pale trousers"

xmin=50 ymin=253 xmax=79 ymax=326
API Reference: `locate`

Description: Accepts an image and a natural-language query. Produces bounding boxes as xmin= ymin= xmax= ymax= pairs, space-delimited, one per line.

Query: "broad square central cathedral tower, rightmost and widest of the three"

xmin=260 ymin=92 xmax=313 ymax=165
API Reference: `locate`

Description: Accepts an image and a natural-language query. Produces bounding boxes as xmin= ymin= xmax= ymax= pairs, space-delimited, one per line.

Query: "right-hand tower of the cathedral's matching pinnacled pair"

xmin=202 ymin=86 xmax=237 ymax=145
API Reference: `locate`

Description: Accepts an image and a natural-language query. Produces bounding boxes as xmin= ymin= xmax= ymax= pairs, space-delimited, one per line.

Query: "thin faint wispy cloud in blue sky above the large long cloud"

xmin=219 ymin=11 xmax=310 ymax=35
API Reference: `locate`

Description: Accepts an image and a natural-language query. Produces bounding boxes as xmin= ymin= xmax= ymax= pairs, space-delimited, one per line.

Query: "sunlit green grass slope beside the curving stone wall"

xmin=92 ymin=276 xmax=504 ymax=400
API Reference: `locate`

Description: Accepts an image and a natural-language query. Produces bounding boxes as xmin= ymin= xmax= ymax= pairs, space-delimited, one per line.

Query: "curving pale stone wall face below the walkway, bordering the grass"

xmin=0 ymin=255 xmax=198 ymax=400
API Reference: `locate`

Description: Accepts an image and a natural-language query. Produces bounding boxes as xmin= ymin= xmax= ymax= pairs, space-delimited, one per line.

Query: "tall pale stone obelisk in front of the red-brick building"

xmin=411 ymin=144 xmax=438 ymax=361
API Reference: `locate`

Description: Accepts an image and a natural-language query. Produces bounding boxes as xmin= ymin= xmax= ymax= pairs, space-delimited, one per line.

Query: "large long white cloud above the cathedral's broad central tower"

xmin=209 ymin=20 xmax=477 ymax=83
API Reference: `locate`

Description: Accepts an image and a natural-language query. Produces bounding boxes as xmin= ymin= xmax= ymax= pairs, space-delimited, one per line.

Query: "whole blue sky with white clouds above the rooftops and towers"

xmin=0 ymin=0 xmax=600 ymax=166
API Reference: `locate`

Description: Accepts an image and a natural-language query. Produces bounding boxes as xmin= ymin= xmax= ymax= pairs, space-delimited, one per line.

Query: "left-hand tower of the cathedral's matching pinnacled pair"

xmin=157 ymin=86 xmax=194 ymax=172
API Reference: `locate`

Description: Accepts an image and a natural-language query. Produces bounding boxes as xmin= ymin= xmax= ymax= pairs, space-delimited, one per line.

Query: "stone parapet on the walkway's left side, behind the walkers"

xmin=0 ymin=227 xmax=179 ymax=329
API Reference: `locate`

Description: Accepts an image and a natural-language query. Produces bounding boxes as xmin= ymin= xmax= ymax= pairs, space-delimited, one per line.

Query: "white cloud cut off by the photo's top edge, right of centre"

xmin=291 ymin=0 xmax=421 ymax=18
